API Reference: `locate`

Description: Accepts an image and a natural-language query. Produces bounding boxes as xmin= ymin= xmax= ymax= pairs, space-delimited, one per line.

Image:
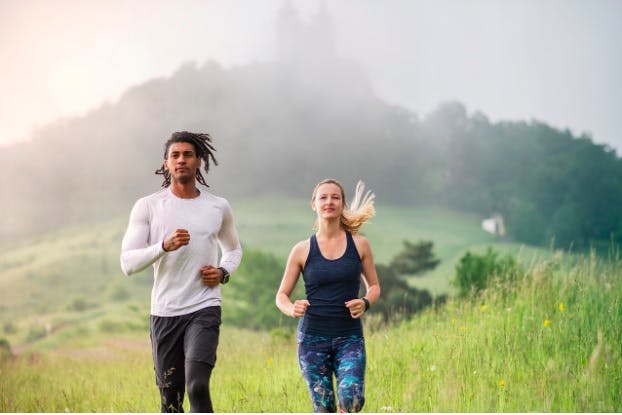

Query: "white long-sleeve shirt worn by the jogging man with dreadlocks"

xmin=121 ymin=188 xmax=242 ymax=317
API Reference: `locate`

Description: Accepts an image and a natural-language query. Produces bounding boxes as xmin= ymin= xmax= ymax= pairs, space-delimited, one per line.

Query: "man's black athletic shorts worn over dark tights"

xmin=151 ymin=306 xmax=221 ymax=388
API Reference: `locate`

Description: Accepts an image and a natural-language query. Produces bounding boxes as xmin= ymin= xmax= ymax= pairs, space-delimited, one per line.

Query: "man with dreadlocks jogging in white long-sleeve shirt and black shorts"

xmin=121 ymin=131 xmax=242 ymax=412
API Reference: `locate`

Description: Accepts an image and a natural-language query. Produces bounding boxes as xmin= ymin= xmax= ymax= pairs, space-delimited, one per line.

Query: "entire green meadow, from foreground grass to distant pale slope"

xmin=0 ymin=199 xmax=622 ymax=413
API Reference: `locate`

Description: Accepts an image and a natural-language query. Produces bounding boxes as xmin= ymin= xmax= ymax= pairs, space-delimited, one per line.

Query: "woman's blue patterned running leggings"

xmin=298 ymin=333 xmax=365 ymax=412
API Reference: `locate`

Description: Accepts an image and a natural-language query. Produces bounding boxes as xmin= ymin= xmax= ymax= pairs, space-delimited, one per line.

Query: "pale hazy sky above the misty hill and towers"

xmin=0 ymin=0 xmax=622 ymax=154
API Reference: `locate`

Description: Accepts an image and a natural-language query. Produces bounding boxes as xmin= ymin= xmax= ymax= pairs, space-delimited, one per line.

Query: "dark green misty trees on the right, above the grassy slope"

xmin=414 ymin=103 xmax=622 ymax=249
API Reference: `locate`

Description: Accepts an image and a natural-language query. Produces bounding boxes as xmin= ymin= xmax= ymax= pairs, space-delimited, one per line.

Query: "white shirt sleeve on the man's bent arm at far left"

xmin=121 ymin=199 xmax=166 ymax=275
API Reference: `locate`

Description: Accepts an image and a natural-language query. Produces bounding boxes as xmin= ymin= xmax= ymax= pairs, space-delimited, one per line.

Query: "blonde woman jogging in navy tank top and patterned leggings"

xmin=276 ymin=179 xmax=380 ymax=412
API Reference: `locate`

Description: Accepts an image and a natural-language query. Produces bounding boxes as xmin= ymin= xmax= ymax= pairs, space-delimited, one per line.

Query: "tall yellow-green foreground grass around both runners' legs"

xmin=0 ymin=250 xmax=622 ymax=412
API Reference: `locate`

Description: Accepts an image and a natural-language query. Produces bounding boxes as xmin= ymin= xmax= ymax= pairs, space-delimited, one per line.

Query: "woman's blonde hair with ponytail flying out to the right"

xmin=311 ymin=179 xmax=376 ymax=235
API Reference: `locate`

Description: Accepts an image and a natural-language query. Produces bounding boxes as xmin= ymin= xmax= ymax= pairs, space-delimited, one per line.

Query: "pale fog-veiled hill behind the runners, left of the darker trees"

xmin=0 ymin=50 xmax=420 ymax=234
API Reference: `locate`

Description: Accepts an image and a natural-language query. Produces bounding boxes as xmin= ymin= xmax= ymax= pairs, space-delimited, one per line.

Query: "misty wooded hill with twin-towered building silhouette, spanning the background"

xmin=0 ymin=4 xmax=622 ymax=247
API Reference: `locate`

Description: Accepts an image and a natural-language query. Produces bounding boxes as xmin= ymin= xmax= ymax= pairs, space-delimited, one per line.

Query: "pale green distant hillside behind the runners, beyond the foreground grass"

xmin=0 ymin=198 xmax=548 ymax=345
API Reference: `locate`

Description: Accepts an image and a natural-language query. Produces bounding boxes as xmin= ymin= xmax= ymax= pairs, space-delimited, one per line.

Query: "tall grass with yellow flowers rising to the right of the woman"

xmin=367 ymin=250 xmax=622 ymax=412
